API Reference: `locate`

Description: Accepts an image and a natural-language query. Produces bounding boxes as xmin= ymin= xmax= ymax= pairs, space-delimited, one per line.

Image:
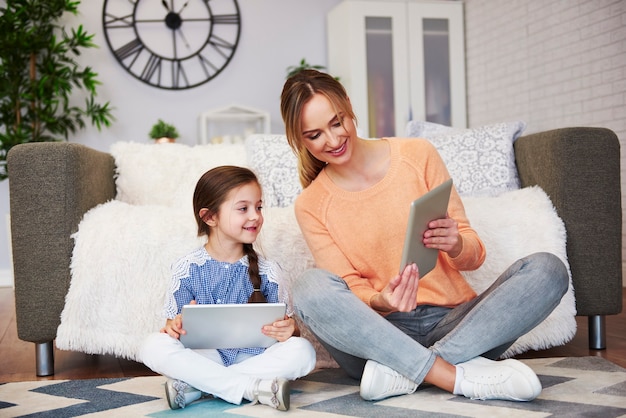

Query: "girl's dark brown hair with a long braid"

xmin=193 ymin=165 xmax=266 ymax=303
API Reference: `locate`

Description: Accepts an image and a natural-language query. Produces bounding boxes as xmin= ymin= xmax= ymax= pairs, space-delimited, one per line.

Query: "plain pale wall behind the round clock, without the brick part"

xmin=0 ymin=0 xmax=340 ymax=286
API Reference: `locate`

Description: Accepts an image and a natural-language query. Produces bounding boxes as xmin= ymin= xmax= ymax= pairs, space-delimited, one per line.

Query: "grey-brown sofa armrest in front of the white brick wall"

xmin=515 ymin=127 xmax=622 ymax=316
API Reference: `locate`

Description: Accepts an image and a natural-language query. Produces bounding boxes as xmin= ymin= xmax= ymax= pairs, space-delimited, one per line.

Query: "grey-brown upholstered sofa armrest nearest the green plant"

xmin=7 ymin=142 xmax=115 ymax=343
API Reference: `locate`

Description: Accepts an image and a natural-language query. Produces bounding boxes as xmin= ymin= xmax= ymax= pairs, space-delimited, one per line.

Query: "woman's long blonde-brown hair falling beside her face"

xmin=280 ymin=70 xmax=356 ymax=187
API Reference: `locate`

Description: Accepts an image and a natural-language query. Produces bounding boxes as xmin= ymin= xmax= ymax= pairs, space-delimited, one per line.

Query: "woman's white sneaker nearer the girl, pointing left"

xmin=361 ymin=360 xmax=417 ymax=401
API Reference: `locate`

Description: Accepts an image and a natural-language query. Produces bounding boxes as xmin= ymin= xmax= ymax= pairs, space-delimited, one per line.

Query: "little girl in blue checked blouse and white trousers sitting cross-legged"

xmin=140 ymin=166 xmax=315 ymax=411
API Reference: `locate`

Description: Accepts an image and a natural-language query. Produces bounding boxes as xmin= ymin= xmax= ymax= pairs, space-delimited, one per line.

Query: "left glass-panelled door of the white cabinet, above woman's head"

xmin=328 ymin=0 xmax=410 ymax=138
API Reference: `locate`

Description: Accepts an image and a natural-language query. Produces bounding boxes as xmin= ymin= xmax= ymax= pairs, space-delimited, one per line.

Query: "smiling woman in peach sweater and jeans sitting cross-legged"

xmin=281 ymin=70 xmax=568 ymax=401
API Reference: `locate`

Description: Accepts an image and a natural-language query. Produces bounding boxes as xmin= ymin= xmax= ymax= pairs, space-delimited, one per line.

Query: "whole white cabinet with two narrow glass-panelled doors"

xmin=327 ymin=0 xmax=467 ymax=137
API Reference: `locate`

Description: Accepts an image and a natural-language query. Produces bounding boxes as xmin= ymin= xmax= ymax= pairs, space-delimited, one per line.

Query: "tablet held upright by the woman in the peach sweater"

xmin=400 ymin=179 xmax=452 ymax=277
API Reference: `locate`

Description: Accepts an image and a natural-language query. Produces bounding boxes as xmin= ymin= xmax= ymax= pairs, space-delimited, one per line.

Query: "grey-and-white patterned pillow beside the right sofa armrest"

xmin=407 ymin=121 xmax=526 ymax=196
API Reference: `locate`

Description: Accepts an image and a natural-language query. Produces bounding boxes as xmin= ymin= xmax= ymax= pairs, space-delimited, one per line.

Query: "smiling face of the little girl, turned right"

xmin=212 ymin=183 xmax=263 ymax=244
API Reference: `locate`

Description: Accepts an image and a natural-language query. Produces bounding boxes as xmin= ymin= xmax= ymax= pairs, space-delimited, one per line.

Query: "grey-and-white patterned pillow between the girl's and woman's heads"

xmin=245 ymin=135 xmax=302 ymax=207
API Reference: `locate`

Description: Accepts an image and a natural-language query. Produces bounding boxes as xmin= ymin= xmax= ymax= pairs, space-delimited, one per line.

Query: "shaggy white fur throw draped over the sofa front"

xmin=56 ymin=187 xmax=576 ymax=367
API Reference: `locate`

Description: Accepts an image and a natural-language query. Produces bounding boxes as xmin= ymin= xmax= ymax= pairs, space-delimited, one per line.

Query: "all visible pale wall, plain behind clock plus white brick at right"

xmin=0 ymin=0 xmax=626 ymax=285
